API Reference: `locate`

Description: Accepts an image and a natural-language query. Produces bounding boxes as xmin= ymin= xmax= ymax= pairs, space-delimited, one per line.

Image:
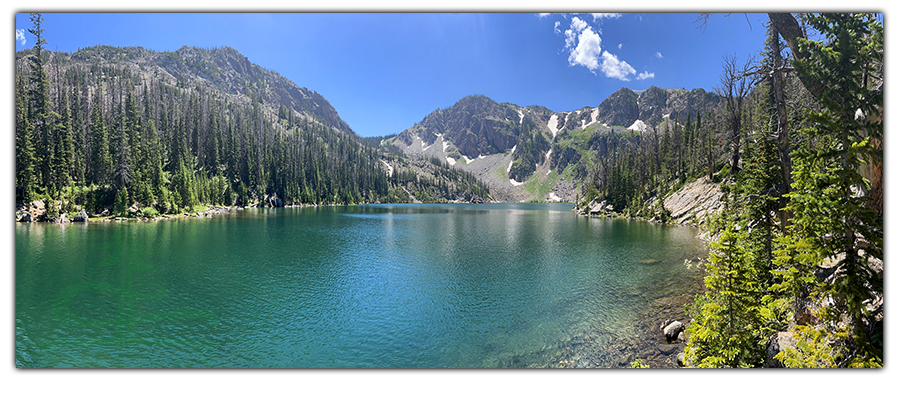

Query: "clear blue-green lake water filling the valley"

xmin=10 ymin=204 xmax=706 ymax=368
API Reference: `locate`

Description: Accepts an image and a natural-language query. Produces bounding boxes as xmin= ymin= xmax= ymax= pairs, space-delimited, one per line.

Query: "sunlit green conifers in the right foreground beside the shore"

xmin=685 ymin=13 xmax=884 ymax=367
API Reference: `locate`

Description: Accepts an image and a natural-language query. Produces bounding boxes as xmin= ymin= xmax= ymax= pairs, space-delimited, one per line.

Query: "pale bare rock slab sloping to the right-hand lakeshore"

xmin=663 ymin=177 xmax=722 ymax=225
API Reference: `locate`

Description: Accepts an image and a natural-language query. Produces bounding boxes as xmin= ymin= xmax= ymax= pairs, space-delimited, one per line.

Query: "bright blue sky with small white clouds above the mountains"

xmin=15 ymin=13 xmax=766 ymax=136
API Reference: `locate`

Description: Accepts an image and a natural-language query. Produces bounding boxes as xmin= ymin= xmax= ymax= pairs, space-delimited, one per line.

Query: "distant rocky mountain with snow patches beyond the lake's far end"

xmin=383 ymin=87 xmax=718 ymax=201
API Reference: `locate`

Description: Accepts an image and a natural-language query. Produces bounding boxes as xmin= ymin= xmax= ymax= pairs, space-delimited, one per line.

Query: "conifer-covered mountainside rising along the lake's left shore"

xmin=15 ymin=15 xmax=489 ymax=220
